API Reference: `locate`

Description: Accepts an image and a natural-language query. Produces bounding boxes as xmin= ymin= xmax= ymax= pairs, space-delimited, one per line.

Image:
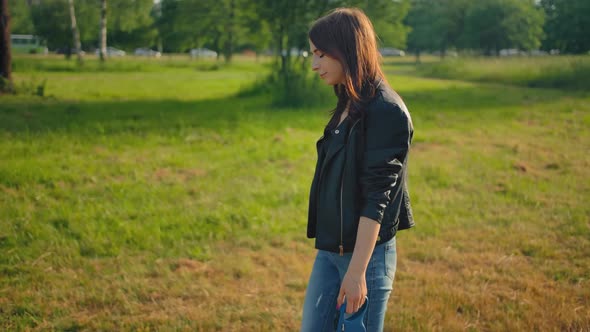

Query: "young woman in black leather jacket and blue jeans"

xmin=301 ymin=8 xmax=414 ymax=332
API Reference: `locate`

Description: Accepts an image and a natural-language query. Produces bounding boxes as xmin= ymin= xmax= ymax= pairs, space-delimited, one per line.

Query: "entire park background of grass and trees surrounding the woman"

xmin=0 ymin=0 xmax=590 ymax=331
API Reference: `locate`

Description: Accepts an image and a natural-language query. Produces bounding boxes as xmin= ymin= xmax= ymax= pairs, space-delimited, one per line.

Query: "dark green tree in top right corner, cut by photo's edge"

xmin=541 ymin=0 xmax=590 ymax=53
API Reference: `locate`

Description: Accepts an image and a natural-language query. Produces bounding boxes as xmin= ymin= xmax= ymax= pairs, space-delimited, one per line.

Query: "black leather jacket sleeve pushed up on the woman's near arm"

xmin=360 ymin=103 xmax=412 ymax=223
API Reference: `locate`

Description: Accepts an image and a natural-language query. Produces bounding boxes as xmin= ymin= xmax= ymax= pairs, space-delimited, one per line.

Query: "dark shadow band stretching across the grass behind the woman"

xmin=0 ymin=82 xmax=565 ymax=134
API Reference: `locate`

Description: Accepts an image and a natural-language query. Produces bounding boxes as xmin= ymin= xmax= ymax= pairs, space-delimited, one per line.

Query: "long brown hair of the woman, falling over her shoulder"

xmin=308 ymin=8 xmax=385 ymax=129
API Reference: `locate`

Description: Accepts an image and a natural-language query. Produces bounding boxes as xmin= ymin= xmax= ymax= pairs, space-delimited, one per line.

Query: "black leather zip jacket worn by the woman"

xmin=307 ymin=84 xmax=414 ymax=254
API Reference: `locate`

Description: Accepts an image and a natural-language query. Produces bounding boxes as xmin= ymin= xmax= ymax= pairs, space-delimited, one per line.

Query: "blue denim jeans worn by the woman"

xmin=301 ymin=237 xmax=397 ymax=332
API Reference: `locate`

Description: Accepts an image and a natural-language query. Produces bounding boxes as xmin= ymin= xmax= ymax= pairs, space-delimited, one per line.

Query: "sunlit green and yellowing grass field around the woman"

xmin=0 ymin=57 xmax=590 ymax=331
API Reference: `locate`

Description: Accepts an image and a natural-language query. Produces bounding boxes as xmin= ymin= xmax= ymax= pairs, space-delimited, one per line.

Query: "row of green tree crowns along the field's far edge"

xmin=9 ymin=0 xmax=590 ymax=56
